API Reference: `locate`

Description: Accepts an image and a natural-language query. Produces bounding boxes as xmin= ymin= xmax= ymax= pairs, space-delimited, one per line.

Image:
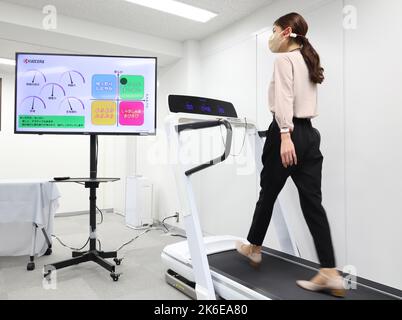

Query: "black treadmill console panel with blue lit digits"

xmin=169 ymin=95 xmax=237 ymax=118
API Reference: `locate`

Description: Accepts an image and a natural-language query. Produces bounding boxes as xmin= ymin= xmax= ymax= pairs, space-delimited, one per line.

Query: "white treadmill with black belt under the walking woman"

xmin=161 ymin=95 xmax=402 ymax=300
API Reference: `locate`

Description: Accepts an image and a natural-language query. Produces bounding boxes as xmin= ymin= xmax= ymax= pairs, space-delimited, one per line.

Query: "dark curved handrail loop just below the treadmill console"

xmin=176 ymin=119 xmax=233 ymax=176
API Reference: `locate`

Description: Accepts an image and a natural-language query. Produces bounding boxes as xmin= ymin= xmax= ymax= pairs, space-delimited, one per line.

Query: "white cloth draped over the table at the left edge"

xmin=0 ymin=179 xmax=60 ymax=256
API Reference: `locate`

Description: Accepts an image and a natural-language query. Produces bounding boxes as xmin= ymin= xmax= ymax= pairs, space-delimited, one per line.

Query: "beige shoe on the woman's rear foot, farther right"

xmin=296 ymin=272 xmax=346 ymax=298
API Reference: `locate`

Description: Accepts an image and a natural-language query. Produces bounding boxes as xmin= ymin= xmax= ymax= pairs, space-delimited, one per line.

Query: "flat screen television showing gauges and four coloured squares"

xmin=14 ymin=53 xmax=157 ymax=135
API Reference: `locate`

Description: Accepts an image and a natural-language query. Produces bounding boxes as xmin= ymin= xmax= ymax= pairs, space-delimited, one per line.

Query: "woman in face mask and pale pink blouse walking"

xmin=236 ymin=13 xmax=345 ymax=296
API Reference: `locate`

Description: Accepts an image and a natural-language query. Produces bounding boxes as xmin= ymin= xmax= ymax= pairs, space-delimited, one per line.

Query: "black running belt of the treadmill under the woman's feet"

xmin=208 ymin=248 xmax=402 ymax=300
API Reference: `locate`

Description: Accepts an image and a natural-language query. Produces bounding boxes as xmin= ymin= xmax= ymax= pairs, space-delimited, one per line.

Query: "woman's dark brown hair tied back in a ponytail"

xmin=275 ymin=12 xmax=325 ymax=84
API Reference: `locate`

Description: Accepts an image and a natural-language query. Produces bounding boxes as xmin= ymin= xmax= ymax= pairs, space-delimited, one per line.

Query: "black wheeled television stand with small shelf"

xmin=44 ymin=135 xmax=121 ymax=281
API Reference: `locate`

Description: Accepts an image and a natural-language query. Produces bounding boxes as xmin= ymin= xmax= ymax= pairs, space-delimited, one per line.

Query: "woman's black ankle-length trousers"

xmin=247 ymin=118 xmax=335 ymax=268
